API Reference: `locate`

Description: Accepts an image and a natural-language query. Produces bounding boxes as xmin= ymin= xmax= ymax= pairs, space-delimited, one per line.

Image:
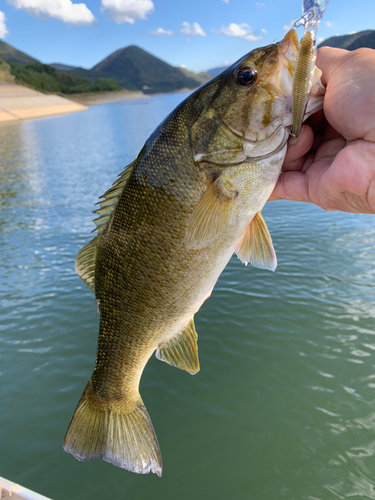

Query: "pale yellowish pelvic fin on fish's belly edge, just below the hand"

xmin=235 ymin=212 xmax=277 ymax=271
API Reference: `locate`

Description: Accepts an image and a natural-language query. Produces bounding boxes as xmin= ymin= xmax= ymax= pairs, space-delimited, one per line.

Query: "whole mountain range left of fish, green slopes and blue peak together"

xmin=0 ymin=40 xmax=209 ymax=93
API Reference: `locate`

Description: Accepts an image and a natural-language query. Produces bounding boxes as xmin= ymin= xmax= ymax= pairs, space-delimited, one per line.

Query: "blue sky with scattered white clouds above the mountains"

xmin=0 ymin=0 xmax=375 ymax=71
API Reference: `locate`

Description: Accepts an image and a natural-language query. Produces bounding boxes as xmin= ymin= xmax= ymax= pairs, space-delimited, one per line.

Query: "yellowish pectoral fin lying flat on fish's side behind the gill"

xmin=185 ymin=176 xmax=238 ymax=250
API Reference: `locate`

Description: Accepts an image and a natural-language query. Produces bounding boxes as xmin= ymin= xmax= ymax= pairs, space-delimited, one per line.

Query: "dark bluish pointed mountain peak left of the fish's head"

xmin=91 ymin=45 xmax=200 ymax=93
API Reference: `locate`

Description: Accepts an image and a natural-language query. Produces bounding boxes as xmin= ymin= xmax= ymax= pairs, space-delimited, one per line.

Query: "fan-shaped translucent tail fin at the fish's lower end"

xmin=63 ymin=391 xmax=163 ymax=477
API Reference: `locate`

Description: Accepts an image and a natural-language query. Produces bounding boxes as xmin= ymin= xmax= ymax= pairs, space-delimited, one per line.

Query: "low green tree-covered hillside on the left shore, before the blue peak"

xmin=10 ymin=61 xmax=120 ymax=94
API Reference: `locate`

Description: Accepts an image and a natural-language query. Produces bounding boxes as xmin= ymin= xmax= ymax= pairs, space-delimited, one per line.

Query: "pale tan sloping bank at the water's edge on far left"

xmin=0 ymin=82 xmax=87 ymax=122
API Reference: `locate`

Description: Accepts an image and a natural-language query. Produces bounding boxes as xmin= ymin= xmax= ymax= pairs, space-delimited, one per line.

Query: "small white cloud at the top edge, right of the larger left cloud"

xmin=101 ymin=0 xmax=154 ymax=24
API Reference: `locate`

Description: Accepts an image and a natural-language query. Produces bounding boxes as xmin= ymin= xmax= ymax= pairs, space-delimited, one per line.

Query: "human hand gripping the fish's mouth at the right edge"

xmin=270 ymin=47 xmax=375 ymax=214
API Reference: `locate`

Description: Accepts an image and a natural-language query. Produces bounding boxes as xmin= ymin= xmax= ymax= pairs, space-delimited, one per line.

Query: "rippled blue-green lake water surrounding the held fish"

xmin=0 ymin=94 xmax=375 ymax=500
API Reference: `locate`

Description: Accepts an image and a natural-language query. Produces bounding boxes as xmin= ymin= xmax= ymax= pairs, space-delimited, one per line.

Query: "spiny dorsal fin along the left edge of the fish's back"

xmin=75 ymin=146 xmax=146 ymax=293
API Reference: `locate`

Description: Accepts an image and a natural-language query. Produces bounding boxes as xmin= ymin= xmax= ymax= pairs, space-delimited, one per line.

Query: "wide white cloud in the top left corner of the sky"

xmin=8 ymin=0 xmax=95 ymax=24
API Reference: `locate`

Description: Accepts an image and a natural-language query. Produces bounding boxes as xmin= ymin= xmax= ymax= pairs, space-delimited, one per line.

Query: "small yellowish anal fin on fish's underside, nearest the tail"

xmin=156 ymin=318 xmax=199 ymax=375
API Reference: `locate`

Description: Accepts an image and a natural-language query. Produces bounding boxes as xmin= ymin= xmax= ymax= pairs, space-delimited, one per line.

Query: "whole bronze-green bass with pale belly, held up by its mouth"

xmin=64 ymin=31 xmax=322 ymax=476
